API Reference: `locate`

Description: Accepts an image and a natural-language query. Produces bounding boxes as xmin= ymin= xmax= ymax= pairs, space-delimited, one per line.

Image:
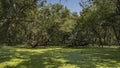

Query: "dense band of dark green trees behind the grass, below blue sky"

xmin=0 ymin=0 xmax=120 ymax=48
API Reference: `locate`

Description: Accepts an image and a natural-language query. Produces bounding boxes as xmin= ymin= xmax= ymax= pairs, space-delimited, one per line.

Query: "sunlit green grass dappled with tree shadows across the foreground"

xmin=0 ymin=46 xmax=120 ymax=68
